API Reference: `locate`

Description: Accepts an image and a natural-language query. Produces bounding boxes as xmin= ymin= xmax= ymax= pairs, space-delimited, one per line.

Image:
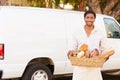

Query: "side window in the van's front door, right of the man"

xmin=103 ymin=18 xmax=120 ymax=39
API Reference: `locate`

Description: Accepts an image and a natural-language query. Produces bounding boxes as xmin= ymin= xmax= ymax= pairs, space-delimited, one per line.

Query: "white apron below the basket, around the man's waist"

xmin=72 ymin=66 xmax=103 ymax=80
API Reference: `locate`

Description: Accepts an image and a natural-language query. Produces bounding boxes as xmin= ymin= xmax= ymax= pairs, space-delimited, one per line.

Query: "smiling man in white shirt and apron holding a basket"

xmin=68 ymin=11 xmax=106 ymax=80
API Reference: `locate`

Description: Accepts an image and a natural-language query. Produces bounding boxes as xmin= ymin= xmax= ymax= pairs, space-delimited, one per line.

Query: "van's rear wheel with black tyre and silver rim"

xmin=21 ymin=63 xmax=52 ymax=80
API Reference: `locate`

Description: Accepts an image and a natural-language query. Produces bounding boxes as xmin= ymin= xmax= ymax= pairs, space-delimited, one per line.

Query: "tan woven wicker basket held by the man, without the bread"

xmin=70 ymin=50 xmax=114 ymax=67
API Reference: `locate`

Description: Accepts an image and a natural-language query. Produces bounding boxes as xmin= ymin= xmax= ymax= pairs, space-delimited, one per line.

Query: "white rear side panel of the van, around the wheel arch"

xmin=0 ymin=8 xmax=67 ymax=78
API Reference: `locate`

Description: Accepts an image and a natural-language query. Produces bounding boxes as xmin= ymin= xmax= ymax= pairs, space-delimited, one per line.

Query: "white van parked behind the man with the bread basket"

xmin=0 ymin=6 xmax=120 ymax=80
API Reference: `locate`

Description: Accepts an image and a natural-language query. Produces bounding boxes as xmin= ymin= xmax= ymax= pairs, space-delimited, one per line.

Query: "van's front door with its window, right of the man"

xmin=103 ymin=18 xmax=120 ymax=69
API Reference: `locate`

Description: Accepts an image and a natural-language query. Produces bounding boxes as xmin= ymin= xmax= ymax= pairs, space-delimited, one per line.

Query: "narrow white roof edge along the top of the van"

xmin=0 ymin=6 xmax=113 ymax=18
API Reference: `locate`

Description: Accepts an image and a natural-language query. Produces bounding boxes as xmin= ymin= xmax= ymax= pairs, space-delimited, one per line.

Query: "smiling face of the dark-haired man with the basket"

xmin=84 ymin=13 xmax=95 ymax=27
